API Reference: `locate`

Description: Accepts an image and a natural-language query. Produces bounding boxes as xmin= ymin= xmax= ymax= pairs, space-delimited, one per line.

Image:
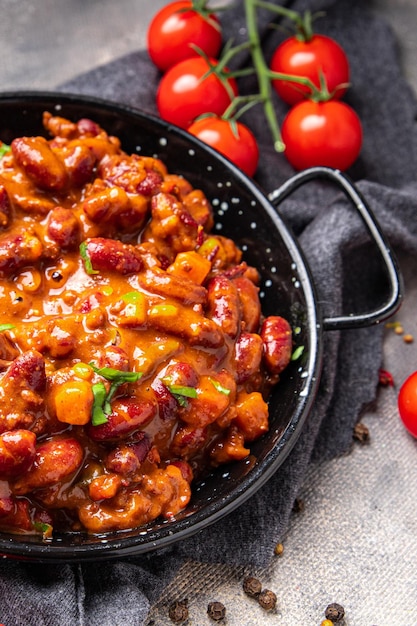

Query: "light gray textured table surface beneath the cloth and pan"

xmin=0 ymin=0 xmax=417 ymax=626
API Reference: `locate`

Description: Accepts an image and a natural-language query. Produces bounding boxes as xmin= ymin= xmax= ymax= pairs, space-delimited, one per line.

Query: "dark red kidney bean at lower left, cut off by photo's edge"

xmin=0 ymin=429 xmax=36 ymax=479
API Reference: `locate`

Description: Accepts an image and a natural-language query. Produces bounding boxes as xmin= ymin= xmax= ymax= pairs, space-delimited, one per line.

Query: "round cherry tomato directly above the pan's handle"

xmin=281 ymin=100 xmax=362 ymax=171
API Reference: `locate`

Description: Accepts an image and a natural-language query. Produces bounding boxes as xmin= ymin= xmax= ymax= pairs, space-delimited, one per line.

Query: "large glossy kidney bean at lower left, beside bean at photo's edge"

xmin=12 ymin=437 xmax=84 ymax=495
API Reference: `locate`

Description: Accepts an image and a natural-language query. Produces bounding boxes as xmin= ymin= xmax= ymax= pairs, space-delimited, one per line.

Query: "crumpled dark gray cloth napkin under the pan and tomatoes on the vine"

xmin=0 ymin=0 xmax=417 ymax=626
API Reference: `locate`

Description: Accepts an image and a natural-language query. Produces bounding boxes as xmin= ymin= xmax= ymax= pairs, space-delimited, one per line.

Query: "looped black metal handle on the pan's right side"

xmin=268 ymin=166 xmax=403 ymax=330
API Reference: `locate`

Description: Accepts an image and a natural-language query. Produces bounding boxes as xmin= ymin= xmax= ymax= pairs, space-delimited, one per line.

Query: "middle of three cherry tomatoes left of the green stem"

xmin=156 ymin=57 xmax=237 ymax=128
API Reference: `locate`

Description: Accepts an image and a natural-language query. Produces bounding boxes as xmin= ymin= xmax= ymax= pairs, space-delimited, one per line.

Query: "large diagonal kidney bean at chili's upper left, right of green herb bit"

xmin=11 ymin=137 xmax=68 ymax=191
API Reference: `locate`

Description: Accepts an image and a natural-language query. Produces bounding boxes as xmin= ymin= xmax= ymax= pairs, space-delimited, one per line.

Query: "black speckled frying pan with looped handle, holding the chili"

xmin=0 ymin=93 xmax=402 ymax=561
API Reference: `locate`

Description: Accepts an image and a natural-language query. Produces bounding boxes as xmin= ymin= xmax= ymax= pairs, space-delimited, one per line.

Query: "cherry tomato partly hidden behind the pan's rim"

xmin=187 ymin=117 xmax=259 ymax=176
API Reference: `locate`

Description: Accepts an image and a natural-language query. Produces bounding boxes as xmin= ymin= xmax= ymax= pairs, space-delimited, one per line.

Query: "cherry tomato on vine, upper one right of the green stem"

xmin=270 ymin=35 xmax=349 ymax=105
